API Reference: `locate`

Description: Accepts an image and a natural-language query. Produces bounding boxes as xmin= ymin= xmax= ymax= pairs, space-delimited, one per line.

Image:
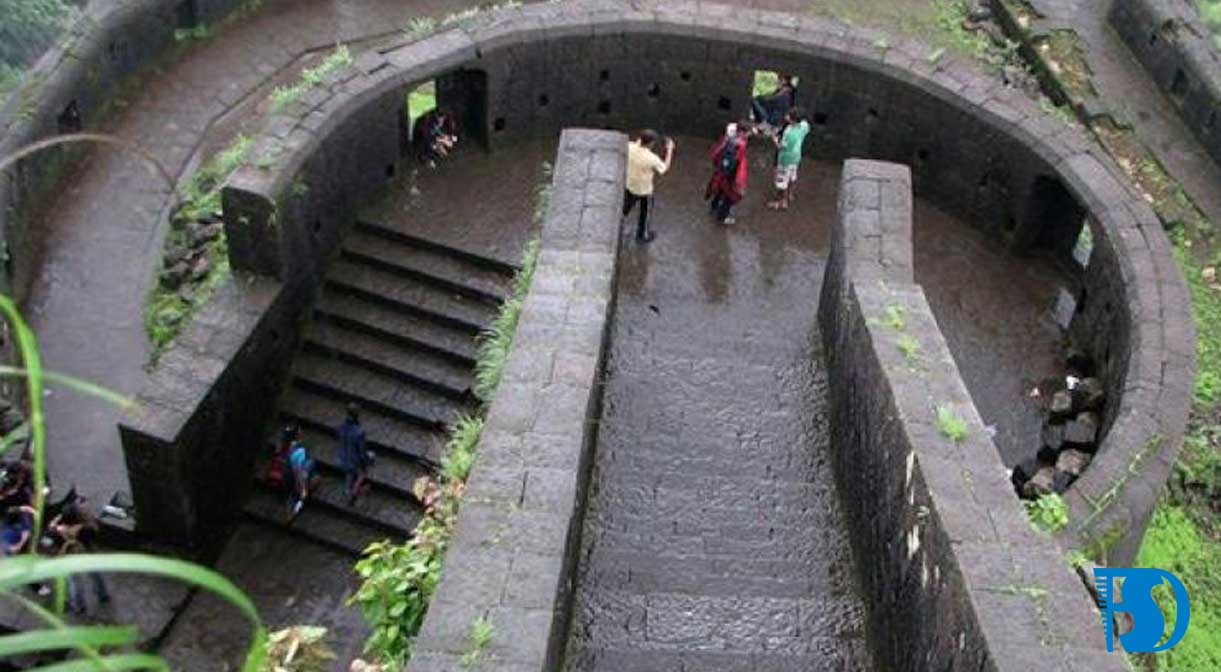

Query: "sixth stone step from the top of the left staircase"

xmin=293 ymin=352 xmax=473 ymax=429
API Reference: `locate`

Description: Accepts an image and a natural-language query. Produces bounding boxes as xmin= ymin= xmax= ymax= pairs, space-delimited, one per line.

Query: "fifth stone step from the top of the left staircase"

xmin=305 ymin=323 xmax=474 ymax=401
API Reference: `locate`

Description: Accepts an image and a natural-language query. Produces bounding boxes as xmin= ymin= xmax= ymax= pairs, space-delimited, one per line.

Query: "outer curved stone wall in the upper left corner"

xmin=0 ymin=0 xmax=242 ymax=299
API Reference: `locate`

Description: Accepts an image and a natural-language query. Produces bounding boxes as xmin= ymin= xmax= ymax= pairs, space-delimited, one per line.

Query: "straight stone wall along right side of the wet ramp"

xmin=819 ymin=160 xmax=1127 ymax=672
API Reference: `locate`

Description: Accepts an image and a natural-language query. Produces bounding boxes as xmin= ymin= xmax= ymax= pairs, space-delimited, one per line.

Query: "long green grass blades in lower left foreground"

xmin=0 ymin=294 xmax=267 ymax=672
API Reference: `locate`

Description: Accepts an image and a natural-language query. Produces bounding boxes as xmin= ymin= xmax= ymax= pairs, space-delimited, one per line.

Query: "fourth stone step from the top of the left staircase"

xmin=314 ymin=287 xmax=479 ymax=367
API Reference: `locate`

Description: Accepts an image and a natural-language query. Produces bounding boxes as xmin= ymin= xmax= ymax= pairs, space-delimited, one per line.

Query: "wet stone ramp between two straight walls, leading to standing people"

xmin=565 ymin=149 xmax=873 ymax=672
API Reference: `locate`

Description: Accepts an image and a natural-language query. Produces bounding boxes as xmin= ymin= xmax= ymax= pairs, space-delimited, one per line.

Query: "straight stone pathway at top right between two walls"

xmin=1029 ymin=0 xmax=1221 ymax=222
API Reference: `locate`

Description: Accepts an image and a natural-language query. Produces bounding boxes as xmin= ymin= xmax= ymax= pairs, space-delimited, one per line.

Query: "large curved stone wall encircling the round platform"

xmin=225 ymin=0 xmax=1194 ymax=563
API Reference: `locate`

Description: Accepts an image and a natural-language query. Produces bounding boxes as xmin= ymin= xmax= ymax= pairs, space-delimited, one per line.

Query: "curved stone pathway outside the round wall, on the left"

xmin=27 ymin=0 xmax=495 ymax=520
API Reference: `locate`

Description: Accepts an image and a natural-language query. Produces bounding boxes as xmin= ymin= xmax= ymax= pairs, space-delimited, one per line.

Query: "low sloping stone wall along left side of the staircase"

xmin=118 ymin=274 xmax=300 ymax=545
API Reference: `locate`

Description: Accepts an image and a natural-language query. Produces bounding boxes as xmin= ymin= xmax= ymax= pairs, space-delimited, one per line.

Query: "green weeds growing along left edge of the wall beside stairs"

xmin=348 ymin=164 xmax=551 ymax=671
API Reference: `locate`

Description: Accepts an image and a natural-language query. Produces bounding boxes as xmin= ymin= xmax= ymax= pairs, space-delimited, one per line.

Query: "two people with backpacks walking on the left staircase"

xmin=267 ymin=403 xmax=374 ymax=519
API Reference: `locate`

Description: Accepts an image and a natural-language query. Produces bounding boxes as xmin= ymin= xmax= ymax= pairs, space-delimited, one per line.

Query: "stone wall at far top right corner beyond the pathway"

xmin=1107 ymin=0 xmax=1221 ymax=163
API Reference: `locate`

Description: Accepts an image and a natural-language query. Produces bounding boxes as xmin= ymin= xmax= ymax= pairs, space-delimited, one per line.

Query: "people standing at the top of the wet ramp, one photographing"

xmin=623 ymin=76 xmax=810 ymax=243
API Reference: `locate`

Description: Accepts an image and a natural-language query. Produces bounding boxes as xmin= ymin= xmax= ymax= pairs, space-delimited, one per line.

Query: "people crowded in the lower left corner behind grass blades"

xmin=0 ymin=455 xmax=110 ymax=615
